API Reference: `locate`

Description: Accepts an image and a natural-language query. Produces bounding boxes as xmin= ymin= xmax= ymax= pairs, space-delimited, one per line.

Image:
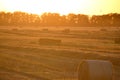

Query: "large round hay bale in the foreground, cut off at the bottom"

xmin=78 ymin=60 xmax=113 ymax=80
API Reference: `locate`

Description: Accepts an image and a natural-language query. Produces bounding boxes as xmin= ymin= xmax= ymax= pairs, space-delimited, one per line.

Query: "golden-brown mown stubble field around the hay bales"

xmin=0 ymin=28 xmax=120 ymax=80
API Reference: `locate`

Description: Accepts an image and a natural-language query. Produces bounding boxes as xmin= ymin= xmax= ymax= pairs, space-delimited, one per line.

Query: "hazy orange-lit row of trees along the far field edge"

xmin=0 ymin=12 xmax=120 ymax=27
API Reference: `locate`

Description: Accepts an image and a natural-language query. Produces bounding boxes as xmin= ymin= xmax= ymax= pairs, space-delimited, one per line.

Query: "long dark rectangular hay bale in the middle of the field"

xmin=39 ymin=38 xmax=62 ymax=45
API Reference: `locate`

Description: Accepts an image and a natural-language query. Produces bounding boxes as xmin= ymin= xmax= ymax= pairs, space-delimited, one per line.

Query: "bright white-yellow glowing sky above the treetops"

xmin=0 ymin=0 xmax=120 ymax=15
